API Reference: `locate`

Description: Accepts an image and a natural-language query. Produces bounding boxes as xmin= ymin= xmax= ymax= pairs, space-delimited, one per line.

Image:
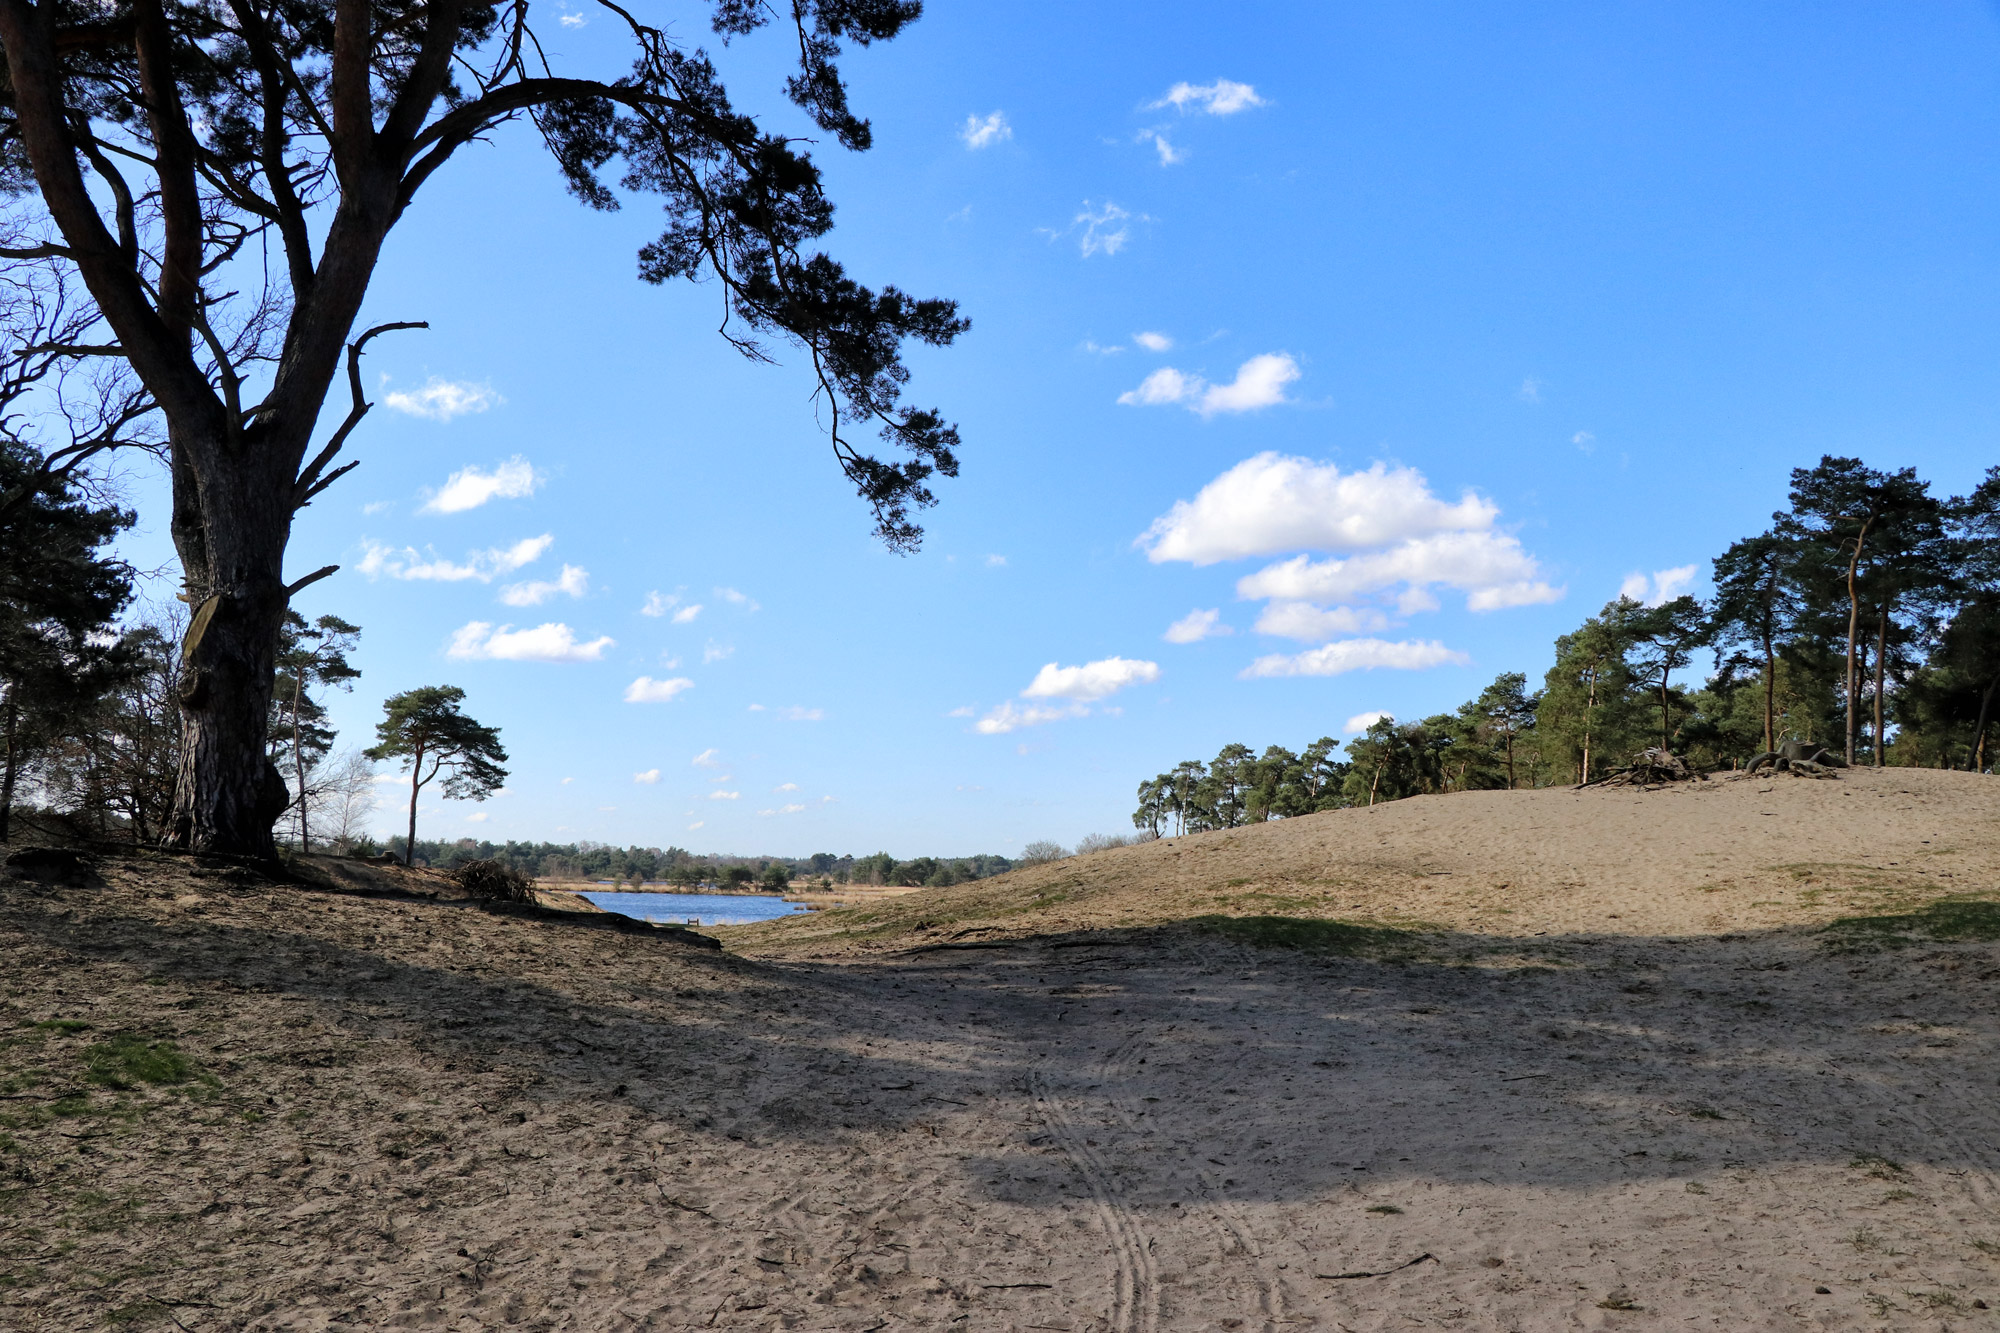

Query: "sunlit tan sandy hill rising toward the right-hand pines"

xmin=726 ymin=769 xmax=2000 ymax=957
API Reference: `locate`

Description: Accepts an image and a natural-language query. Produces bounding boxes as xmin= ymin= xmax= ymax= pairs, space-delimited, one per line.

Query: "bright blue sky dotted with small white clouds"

xmin=113 ymin=0 xmax=2000 ymax=857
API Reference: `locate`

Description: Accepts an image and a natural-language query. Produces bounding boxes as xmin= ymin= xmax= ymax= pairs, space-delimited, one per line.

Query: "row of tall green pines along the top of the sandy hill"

xmin=1132 ymin=456 xmax=2000 ymax=833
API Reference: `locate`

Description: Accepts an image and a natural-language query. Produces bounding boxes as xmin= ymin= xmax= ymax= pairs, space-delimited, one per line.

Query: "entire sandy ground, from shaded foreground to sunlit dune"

xmin=0 ymin=773 xmax=2000 ymax=1331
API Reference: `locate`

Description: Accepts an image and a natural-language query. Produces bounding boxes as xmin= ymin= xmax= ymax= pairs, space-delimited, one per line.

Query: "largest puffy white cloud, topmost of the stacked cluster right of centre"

xmin=1140 ymin=452 xmax=1500 ymax=564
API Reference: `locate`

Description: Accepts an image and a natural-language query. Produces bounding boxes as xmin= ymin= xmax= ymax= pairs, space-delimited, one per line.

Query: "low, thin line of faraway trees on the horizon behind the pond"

xmin=378 ymin=839 xmax=1014 ymax=889
